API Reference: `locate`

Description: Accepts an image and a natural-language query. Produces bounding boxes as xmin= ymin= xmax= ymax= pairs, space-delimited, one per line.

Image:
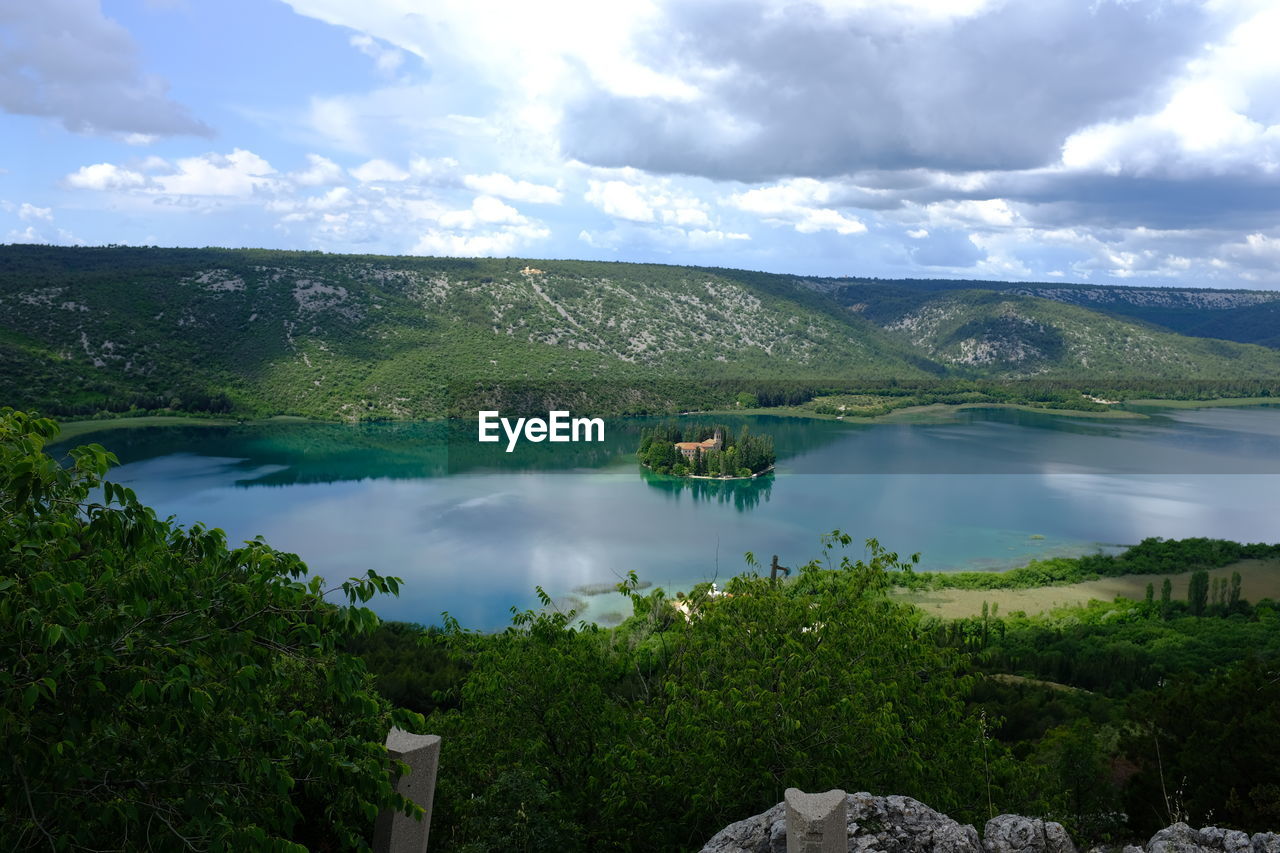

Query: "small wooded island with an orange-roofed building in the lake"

xmin=636 ymin=424 xmax=777 ymax=480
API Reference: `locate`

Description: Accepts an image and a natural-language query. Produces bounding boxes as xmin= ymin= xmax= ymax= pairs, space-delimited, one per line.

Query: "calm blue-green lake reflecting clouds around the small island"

xmin=55 ymin=406 xmax=1280 ymax=630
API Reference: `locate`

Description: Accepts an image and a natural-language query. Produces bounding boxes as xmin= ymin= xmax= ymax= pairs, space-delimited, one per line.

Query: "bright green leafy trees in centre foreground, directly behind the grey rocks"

xmin=430 ymin=534 xmax=1025 ymax=850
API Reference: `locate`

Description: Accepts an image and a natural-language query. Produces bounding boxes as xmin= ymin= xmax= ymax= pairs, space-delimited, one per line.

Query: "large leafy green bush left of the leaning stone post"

xmin=0 ymin=409 xmax=422 ymax=850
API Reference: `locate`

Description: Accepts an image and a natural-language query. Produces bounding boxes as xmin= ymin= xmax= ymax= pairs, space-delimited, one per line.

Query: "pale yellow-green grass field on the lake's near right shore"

xmin=893 ymin=560 xmax=1280 ymax=619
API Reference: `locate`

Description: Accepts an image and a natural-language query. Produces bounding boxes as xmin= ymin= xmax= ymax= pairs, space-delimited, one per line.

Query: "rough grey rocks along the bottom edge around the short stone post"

xmin=701 ymin=793 xmax=1280 ymax=853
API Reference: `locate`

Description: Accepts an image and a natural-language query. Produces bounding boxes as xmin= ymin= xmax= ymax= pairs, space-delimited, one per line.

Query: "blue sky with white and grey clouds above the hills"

xmin=0 ymin=0 xmax=1280 ymax=289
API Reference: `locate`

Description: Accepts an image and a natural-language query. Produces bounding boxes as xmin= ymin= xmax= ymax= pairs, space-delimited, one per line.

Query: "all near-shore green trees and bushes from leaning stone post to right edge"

xmin=355 ymin=532 xmax=1280 ymax=850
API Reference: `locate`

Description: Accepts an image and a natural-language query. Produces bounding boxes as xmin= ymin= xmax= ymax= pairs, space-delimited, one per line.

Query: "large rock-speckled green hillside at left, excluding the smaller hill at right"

xmin=0 ymin=246 xmax=929 ymax=418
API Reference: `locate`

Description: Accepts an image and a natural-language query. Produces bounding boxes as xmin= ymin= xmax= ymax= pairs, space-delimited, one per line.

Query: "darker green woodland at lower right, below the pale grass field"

xmin=947 ymin=593 xmax=1280 ymax=839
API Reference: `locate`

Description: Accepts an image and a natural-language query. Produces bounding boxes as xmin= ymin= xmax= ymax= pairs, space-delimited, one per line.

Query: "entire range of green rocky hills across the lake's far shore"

xmin=0 ymin=246 xmax=1280 ymax=419
